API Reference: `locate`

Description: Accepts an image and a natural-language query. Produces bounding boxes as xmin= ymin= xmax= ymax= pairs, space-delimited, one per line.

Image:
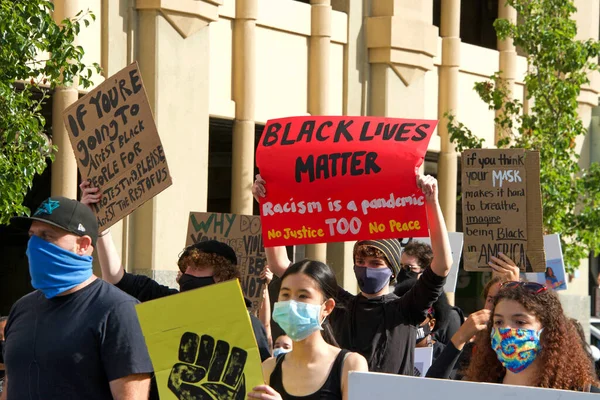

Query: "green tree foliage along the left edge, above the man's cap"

xmin=0 ymin=0 xmax=100 ymax=224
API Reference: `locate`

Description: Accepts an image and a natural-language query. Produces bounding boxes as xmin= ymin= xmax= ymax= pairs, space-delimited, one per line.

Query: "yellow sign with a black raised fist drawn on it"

xmin=136 ymin=280 xmax=264 ymax=400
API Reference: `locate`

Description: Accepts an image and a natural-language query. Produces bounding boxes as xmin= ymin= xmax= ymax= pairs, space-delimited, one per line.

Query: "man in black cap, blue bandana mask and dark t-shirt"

xmin=0 ymin=197 xmax=153 ymax=399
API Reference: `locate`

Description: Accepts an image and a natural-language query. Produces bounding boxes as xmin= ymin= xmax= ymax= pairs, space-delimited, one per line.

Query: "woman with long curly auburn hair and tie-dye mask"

xmin=465 ymin=281 xmax=600 ymax=392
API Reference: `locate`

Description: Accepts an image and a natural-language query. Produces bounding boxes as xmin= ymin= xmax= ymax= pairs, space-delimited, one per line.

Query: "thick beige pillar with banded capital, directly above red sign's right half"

xmin=365 ymin=0 xmax=438 ymax=118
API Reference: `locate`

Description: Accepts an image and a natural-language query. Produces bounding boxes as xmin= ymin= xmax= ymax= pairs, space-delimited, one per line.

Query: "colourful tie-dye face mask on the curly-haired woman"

xmin=490 ymin=328 xmax=542 ymax=374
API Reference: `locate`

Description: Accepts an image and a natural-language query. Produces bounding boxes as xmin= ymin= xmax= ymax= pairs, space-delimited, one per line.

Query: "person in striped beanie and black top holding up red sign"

xmin=252 ymin=175 xmax=452 ymax=375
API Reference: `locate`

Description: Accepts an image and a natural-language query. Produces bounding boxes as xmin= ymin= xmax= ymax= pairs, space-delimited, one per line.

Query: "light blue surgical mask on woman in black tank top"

xmin=273 ymin=300 xmax=323 ymax=342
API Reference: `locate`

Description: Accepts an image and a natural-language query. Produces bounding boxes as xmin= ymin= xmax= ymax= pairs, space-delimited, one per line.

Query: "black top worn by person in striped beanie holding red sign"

xmin=330 ymin=268 xmax=446 ymax=376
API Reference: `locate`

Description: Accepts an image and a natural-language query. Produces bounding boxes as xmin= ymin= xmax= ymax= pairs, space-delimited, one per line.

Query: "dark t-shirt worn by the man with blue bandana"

xmin=4 ymin=279 xmax=153 ymax=400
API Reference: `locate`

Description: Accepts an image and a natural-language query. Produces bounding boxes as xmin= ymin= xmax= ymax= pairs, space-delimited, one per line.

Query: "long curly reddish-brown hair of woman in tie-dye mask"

xmin=465 ymin=286 xmax=597 ymax=391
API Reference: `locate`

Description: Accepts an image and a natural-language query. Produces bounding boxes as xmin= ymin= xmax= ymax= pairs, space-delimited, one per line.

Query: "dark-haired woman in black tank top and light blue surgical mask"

xmin=248 ymin=260 xmax=368 ymax=400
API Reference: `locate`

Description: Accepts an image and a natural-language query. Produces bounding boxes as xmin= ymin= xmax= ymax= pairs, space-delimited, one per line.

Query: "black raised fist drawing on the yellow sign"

xmin=168 ymin=332 xmax=248 ymax=400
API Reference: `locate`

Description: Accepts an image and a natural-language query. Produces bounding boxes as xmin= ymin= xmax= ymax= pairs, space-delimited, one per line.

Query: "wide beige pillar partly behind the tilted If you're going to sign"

xmin=128 ymin=0 xmax=219 ymax=287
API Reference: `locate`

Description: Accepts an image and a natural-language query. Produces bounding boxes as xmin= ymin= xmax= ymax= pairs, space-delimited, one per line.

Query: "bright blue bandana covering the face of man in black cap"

xmin=27 ymin=236 xmax=92 ymax=299
